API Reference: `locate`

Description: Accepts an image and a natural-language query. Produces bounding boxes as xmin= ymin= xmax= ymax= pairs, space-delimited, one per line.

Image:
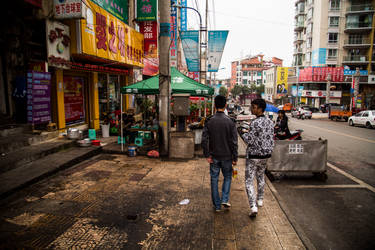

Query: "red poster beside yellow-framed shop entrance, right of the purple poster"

xmin=64 ymin=76 xmax=85 ymax=124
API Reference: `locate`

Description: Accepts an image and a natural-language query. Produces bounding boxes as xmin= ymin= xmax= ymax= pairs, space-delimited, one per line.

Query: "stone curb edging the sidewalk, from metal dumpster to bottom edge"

xmin=266 ymin=180 xmax=316 ymax=250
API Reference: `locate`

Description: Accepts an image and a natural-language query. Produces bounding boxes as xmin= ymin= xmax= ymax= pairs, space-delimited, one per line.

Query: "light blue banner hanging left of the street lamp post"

xmin=180 ymin=30 xmax=199 ymax=72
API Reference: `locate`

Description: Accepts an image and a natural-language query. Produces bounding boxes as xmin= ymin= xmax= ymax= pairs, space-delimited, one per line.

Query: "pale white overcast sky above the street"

xmin=187 ymin=0 xmax=295 ymax=79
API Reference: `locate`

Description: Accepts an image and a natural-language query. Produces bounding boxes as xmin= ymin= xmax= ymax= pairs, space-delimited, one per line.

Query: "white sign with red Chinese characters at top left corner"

xmin=54 ymin=0 xmax=86 ymax=19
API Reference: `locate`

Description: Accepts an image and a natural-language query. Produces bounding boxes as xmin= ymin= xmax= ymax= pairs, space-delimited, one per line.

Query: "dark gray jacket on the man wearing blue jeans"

xmin=202 ymin=112 xmax=238 ymax=161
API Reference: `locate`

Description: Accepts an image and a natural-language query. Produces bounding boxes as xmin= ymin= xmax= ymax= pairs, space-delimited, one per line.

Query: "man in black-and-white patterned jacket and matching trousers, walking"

xmin=243 ymin=99 xmax=274 ymax=217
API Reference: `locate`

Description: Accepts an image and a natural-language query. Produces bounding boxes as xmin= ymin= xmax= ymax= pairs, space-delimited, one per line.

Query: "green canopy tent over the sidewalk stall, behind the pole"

xmin=121 ymin=68 xmax=214 ymax=96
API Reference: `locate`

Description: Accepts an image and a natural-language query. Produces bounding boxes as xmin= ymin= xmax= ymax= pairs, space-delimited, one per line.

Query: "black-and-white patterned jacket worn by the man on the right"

xmin=242 ymin=115 xmax=275 ymax=159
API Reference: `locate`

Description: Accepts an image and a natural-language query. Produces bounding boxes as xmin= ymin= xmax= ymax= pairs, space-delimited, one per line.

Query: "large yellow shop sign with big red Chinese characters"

xmin=80 ymin=0 xmax=144 ymax=67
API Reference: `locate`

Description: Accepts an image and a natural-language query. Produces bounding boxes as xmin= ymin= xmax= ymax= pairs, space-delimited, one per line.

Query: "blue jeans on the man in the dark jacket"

xmin=210 ymin=159 xmax=233 ymax=209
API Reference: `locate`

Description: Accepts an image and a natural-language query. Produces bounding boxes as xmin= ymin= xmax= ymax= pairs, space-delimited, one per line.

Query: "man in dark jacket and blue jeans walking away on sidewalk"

xmin=202 ymin=95 xmax=238 ymax=212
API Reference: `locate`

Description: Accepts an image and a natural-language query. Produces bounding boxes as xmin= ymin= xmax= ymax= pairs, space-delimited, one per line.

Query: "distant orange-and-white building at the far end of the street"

xmin=231 ymin=54 xmax=283 ymax=89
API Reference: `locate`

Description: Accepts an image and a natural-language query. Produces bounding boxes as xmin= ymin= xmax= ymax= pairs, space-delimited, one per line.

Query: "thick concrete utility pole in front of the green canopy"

xmin=158 ymin=0 xmax=171 ymax=156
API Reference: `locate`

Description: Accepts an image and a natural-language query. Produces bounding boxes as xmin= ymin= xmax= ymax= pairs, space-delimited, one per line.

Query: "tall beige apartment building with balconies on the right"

xmin=293 ymin=0 xmax=375 ymax=108
